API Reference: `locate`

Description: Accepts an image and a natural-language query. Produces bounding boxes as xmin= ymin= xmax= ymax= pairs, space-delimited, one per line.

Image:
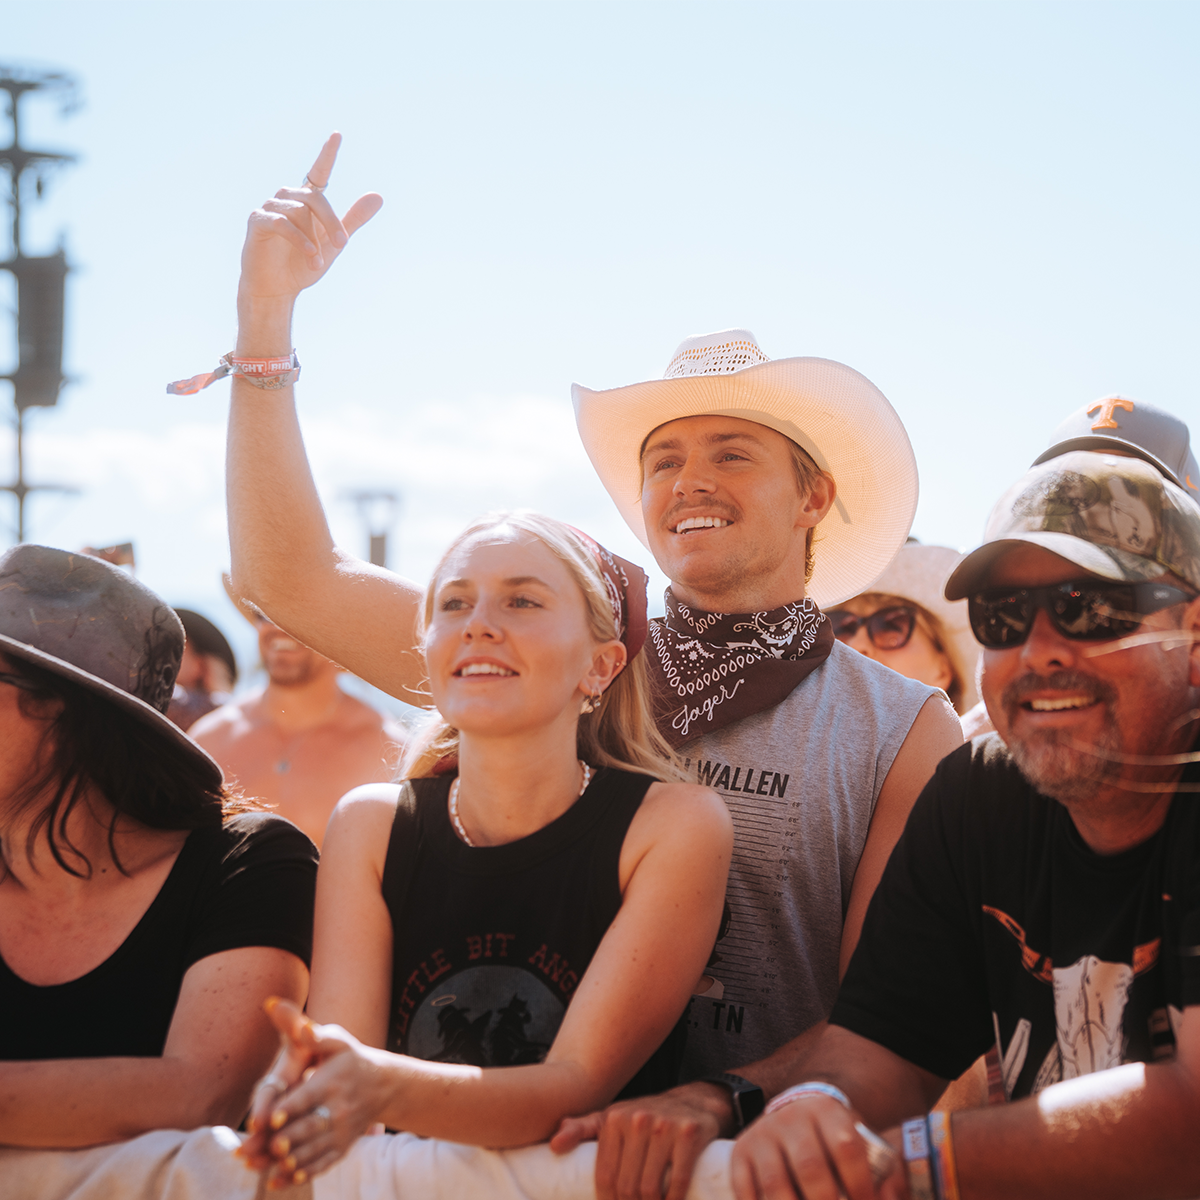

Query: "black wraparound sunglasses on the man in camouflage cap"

xmin=967 ymin=580 xmax=1192 ymax=650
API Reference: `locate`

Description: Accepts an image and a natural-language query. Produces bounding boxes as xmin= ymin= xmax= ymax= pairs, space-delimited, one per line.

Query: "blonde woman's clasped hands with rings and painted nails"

xmin=235 ymin=996 xmax=385 ymax=1190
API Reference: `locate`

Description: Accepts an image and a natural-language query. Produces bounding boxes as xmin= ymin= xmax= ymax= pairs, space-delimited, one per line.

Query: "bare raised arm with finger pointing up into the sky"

xmin=226 ymin=133 xmax=425 ymax=701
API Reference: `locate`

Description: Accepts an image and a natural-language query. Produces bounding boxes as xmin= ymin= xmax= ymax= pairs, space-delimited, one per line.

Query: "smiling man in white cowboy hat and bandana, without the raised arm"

xmin=554 ymin=330 xmax=962 ymax=1198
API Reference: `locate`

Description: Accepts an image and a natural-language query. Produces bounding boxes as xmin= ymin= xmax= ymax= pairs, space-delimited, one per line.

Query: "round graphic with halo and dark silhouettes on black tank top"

xmin=406 ymin=965 xmax=566 ymax=1067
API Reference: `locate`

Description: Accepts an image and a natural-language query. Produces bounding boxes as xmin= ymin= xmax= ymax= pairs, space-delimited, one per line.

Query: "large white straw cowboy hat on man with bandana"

xmin=571 ymin=329 xmax=917 ymax=607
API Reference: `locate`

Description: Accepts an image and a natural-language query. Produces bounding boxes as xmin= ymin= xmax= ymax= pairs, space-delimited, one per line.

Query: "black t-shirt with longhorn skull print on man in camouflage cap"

xmin=830 ymin=734 xmax=1200 ymax=1098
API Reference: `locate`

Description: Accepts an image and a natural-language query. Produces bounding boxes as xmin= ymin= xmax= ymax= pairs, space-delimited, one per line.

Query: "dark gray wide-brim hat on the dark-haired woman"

xmin=0 ymin=544 xmax=223 ymax=782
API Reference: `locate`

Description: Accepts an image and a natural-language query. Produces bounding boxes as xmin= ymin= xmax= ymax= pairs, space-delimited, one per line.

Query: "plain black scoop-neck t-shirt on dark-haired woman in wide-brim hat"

xmin=0 ymin=812 xmax=317 ymax=1061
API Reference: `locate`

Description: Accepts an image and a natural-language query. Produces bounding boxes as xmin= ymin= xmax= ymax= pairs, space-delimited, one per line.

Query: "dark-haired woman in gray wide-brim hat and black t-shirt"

xmin=0 ymin=545 xmax=316 ymax=1147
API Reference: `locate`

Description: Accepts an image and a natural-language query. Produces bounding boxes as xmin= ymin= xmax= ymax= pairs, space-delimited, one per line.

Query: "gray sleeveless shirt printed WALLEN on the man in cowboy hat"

xmin=679 ymin=642 xmax=941 ymax=1080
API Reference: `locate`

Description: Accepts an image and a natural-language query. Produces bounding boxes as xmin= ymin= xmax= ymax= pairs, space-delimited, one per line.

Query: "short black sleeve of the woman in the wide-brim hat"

xmin=184 ymin=812 xmax=317 ymax=971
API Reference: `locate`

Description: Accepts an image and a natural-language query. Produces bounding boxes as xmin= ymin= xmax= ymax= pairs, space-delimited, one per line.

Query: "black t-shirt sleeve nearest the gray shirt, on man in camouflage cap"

xmin=830 ymin=744 xmax=994 ymax=1079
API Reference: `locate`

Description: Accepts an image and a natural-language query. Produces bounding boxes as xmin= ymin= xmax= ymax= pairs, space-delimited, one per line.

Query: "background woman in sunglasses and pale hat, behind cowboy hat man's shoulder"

xmin=826 ymin=540 xmax=982 ymax=737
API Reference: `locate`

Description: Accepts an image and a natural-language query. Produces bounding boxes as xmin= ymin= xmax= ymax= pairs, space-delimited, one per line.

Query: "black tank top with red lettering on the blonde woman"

xmin=383 ymin=768 xmax=685 ymax=1097
